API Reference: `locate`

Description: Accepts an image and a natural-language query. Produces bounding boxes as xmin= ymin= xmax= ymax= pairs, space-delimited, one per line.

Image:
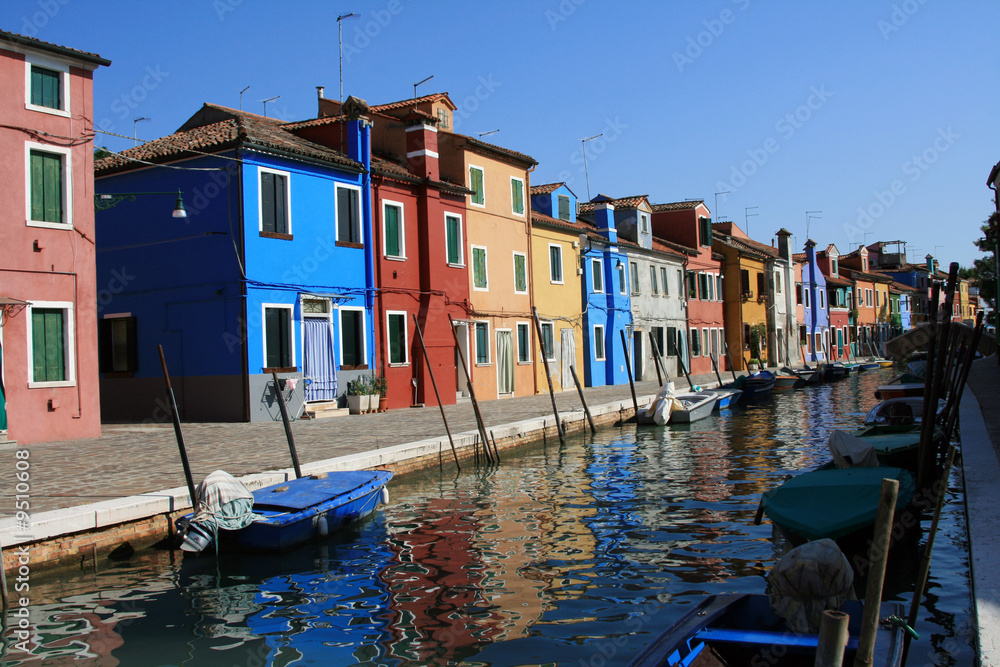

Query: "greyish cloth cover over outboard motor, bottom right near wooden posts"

xmin=767 ymin=539 xmax=854 ymax=633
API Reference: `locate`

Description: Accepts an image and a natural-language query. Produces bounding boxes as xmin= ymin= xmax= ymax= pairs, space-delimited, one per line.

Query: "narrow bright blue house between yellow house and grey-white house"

xmin=580 ymin=202 xmax=632 ymax=387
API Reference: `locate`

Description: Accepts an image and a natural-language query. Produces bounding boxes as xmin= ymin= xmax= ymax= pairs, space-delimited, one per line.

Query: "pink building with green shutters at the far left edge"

xmin=0 ymin=31 xmax=111 ymax=444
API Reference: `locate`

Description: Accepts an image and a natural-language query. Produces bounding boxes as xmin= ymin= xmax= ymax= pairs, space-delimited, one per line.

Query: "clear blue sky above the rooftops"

xmin=0 ymin=0 xmax=1000 ymax=266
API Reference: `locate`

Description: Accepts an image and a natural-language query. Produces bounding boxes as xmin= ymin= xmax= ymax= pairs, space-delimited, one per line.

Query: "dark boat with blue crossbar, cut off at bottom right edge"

xmin=630 ymin=594 xmax=904 ymax=667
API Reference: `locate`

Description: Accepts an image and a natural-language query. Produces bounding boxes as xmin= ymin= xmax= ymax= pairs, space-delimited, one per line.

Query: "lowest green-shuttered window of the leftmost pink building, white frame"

xmin=28 ymin=301 xmax=75 ymax=387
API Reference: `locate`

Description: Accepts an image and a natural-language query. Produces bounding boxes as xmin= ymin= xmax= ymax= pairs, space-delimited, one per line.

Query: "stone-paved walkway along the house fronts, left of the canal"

xmin=0 ymin=375 xmax=725 ymax=517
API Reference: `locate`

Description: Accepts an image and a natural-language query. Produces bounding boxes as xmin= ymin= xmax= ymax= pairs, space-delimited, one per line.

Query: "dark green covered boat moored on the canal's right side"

xmin=761 ymin=467 xmax=916 ymax=544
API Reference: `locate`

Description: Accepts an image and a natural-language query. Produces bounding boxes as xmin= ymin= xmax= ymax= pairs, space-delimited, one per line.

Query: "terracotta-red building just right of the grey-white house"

xmin=652 ymin=201 xmax=728 ymax=375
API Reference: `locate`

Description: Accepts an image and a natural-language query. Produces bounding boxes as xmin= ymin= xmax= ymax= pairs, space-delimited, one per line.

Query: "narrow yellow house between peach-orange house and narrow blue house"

xmin=531 ymin=183 xmax=592 ymax=392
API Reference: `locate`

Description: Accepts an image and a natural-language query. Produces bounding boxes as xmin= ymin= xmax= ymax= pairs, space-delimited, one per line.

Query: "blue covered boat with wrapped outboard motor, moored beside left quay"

xmin=177 ymin=470 xmax=392 ymax=553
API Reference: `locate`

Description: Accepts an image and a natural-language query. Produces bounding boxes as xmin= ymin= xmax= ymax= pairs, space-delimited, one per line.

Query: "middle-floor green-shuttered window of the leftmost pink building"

xmin=25 ymin=143 xmax=73 ymax=227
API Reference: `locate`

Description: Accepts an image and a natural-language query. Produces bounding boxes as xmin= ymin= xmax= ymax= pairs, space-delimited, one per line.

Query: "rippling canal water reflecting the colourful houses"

xmin=3 ymin=371 xmax=975 ymax=667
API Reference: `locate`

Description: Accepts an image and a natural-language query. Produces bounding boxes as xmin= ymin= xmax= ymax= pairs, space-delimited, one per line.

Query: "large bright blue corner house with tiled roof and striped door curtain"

xmin=95 ymin=98 xmax=375 ymax=421
